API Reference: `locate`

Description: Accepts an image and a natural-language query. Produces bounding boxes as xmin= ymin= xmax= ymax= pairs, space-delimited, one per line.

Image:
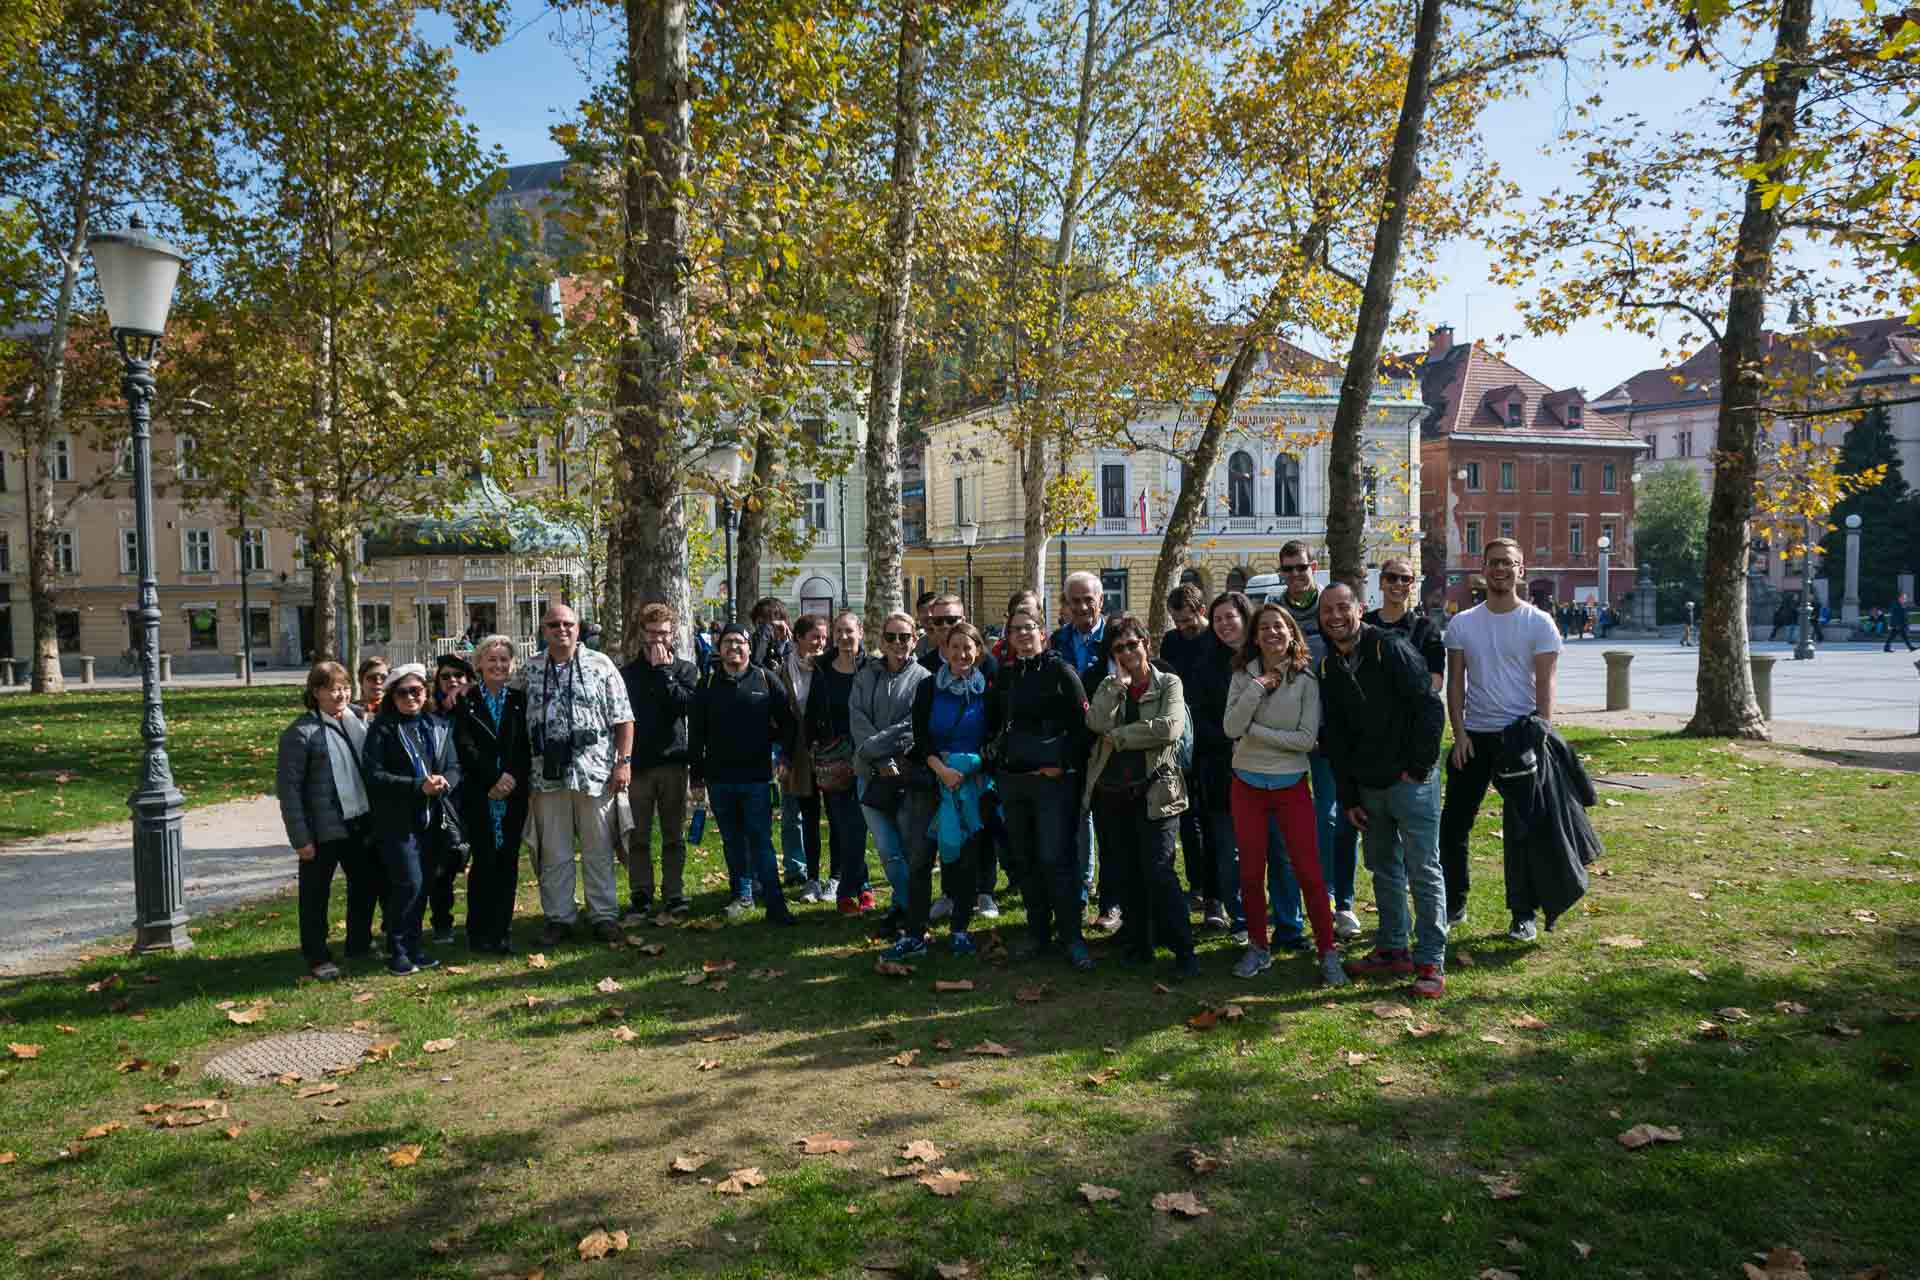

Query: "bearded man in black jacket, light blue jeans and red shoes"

xmin=1317 ymin=583 xmax=1446 ymax=998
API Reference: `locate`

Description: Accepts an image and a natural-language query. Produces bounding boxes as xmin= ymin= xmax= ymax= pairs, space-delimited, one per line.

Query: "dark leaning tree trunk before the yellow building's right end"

xmin=1327 ymin=0 xmax=1442 ymax=587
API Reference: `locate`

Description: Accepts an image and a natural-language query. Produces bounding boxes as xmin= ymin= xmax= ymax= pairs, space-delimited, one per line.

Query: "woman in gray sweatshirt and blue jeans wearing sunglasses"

xmin=847 ymin=610 xmax=933 ymax=936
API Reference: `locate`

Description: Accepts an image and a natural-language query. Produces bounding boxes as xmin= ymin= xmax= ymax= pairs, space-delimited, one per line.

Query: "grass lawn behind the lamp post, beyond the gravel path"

xmin=0 ymin=685 xmax=301 ymax=841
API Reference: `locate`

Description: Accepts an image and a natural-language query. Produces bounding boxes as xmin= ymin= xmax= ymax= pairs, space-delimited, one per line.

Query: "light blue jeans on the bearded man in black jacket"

xmin=1359 ymin=770 xmax=1446 ymax=965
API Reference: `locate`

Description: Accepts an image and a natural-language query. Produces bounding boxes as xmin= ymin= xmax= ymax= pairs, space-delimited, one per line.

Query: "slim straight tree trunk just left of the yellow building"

xmin=866 ymin=0 xmax=927 ymax=635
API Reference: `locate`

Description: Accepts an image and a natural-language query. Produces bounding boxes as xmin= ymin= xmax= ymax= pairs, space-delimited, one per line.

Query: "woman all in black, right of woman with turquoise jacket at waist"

xmin=993 ymin=610 xmax=1092 ymax=973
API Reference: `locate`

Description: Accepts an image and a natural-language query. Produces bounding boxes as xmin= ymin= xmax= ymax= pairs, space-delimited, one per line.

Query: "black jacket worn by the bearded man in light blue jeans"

xmin=1313 ymin=622 xmax=1446 ymax=808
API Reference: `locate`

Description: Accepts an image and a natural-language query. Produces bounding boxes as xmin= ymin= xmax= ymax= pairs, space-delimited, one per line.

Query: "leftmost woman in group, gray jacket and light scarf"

xmin=275 ymin=662 xmax=382 ymax=983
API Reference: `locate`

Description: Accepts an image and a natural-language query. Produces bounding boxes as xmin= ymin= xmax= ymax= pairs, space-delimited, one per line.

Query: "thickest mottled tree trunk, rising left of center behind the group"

xmin=612 ymin=0 xmax=693 ymax=656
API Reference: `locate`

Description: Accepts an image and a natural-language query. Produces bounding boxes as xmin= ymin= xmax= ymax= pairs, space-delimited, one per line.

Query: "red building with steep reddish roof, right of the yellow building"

xmin=1407 ymin=328 xmax=1645 ymax=610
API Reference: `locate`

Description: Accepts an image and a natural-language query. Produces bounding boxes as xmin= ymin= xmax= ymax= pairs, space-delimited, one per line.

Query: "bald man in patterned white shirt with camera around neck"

xmin=526 ymin=604 xmax=634 ymax=946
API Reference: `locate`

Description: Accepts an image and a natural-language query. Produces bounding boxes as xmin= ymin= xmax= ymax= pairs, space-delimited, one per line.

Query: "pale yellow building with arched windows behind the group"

xmin=904 ymin=363 xmax=1425 ymax=624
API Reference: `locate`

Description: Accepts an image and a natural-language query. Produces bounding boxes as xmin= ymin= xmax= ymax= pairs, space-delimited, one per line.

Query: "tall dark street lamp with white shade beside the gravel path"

xmin=86 ymin=217 xmax=194 ymax=952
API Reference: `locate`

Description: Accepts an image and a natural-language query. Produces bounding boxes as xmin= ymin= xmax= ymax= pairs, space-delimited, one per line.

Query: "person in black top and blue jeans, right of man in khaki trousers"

xmin=687 ymin=622 xmax=799 ymax=925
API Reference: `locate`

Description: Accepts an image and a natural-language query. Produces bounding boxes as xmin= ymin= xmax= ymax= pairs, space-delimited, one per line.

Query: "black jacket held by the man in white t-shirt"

xmin=1494 ymin=716 xmax=1603 ymax=929
